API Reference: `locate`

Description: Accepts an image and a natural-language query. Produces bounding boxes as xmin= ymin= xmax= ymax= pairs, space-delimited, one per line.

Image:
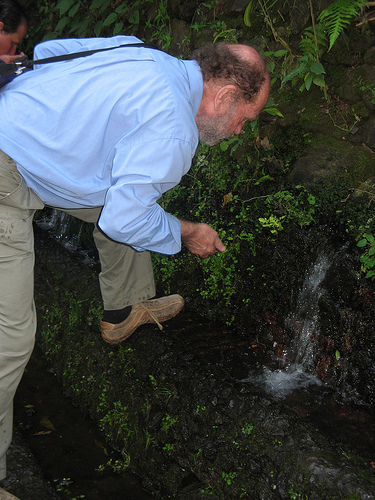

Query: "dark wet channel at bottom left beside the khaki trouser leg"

xmin=8 ymin=348 xmax=153 ymax=500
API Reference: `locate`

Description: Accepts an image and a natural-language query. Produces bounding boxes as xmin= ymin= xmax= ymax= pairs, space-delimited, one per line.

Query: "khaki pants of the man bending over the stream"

xmin=0 ymin=151 xmax=155 ymax=480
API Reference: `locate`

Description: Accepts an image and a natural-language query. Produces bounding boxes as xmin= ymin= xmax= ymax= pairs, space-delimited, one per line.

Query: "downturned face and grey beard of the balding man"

xmin=195 ymin=93 xmax=268 ymax=146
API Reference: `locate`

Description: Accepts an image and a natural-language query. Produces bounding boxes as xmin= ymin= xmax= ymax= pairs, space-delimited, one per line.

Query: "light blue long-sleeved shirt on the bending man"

xmin=0 ymin=36 xmax=203 ymax=254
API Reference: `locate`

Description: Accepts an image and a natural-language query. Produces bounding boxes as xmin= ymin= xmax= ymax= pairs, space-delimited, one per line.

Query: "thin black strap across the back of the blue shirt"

xmin=0 ymin=42 xmax=161 ymax=76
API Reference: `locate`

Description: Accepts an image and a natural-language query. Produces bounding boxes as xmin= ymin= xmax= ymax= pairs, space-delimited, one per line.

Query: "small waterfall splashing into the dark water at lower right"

xmin=241 ymin=246 xmax=375 ymax=468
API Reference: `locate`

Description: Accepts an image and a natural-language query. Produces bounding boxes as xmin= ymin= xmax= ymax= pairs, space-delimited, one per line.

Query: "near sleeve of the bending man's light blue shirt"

xmin=99 ymin=138 xmax=194 ymax=255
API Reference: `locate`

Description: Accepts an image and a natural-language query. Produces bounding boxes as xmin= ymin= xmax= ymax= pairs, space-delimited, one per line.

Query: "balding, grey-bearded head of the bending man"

xmin=192 ymin=44 xmax=270 ymax=146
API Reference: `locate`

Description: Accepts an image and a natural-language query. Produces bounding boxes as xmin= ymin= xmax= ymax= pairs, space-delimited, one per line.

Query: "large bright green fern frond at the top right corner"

xmin=318 ymin=0 xmax=367 ymax=51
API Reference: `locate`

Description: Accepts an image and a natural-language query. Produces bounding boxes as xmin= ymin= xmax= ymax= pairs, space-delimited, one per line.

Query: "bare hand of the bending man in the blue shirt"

xmin=180 ymin=220 xmax=225 ymax=259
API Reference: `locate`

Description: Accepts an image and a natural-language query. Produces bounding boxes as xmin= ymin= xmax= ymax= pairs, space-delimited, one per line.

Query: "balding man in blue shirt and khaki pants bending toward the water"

xmin=0 ymin=36 xmax=270 ymax=479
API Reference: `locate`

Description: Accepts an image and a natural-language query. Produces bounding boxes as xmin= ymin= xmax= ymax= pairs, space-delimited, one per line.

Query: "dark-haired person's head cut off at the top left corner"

xmin=0 ymin=0 xmax=27 ymax=63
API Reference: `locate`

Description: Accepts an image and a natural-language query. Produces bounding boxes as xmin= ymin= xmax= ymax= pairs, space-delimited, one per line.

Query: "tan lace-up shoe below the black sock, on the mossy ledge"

xmin=100 ymin=294 xmax=184 ymax=344
